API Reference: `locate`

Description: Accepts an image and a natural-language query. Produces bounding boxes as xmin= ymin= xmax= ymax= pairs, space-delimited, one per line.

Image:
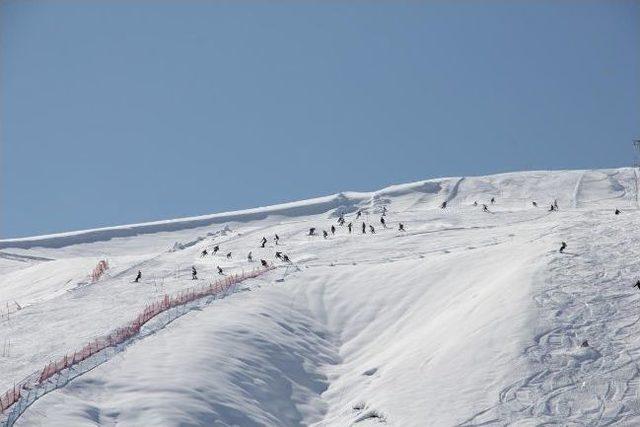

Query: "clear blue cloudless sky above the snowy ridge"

xmin=0 ymin=0 xmax=640 ymax=237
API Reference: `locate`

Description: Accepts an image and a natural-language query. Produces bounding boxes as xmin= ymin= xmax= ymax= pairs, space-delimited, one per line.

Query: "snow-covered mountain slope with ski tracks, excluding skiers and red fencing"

xmin=0 ymin=169 xmax=640 ymax=426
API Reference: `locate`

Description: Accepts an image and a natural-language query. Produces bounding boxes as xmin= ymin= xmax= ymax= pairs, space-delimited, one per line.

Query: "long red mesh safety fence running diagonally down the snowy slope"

xmin=0 ymin=266 xmax=275 ymax=427
